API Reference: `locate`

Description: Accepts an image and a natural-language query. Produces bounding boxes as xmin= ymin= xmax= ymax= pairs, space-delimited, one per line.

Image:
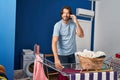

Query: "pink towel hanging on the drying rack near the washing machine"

xmin=33 ymin=54 xmax=48 ymax=80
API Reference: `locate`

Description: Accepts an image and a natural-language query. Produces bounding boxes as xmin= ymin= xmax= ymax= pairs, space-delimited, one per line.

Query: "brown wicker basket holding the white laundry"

xmin=78 ymin=55 xmax=104 ymax=70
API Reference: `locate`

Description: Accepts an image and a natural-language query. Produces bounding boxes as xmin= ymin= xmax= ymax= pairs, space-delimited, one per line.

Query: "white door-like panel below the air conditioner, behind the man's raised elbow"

xmin=76 ymin=19 xmax=91 ymax=51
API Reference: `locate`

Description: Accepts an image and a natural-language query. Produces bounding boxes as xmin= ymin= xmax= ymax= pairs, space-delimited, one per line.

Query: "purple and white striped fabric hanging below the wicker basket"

xmin=70 ymin=71 xmax=117 ymax=80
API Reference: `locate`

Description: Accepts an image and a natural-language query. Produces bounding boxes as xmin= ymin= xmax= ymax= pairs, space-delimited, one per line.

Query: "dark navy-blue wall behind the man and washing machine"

xmin=15 ymin=0 xmax=91 ymax=69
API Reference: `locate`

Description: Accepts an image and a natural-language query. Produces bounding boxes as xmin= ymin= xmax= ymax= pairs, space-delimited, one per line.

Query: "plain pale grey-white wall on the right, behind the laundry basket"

xmin=94 ymin=0 xmax=120 ymax=57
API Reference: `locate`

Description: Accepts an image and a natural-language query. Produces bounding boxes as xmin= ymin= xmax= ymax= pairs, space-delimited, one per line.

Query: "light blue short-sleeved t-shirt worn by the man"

xmin=53 ymin=20 xmax=76 ymax=55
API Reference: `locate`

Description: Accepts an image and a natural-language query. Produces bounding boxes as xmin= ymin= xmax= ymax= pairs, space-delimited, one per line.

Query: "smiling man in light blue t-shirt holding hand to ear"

xmin=52 ymin=6 xmax=84 ymax=70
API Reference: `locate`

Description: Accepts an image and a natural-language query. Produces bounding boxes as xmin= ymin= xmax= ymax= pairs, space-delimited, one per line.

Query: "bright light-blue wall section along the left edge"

xmin=0 ymin=0 xmax=16 ymax=80
